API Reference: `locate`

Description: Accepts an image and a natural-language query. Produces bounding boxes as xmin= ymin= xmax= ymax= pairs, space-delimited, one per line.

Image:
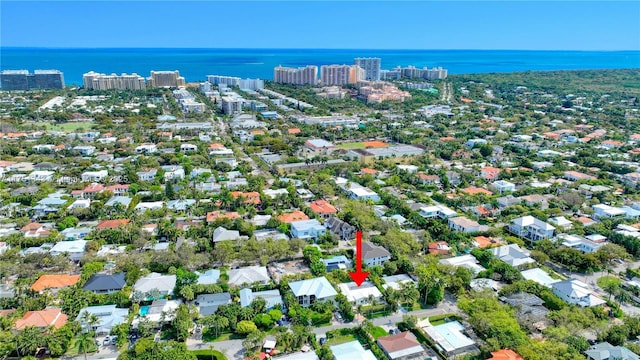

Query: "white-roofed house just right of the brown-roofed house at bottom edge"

xmin=422 ymin=321 xmax=478 ymax=358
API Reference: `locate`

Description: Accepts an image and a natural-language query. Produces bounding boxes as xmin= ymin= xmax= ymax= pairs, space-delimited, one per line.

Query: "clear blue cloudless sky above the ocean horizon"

xmin=0 ymin=0 xmax=640 ymax=50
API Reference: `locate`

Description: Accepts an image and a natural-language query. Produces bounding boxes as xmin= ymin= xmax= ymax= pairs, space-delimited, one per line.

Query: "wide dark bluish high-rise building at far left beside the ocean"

xmin=0 ymin=70 xmax=64 ymax=90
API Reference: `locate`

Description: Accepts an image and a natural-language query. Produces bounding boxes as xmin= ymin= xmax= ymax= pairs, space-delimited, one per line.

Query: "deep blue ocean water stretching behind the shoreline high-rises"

xmin=0 ymin=47 xmax=640 ymax=84
